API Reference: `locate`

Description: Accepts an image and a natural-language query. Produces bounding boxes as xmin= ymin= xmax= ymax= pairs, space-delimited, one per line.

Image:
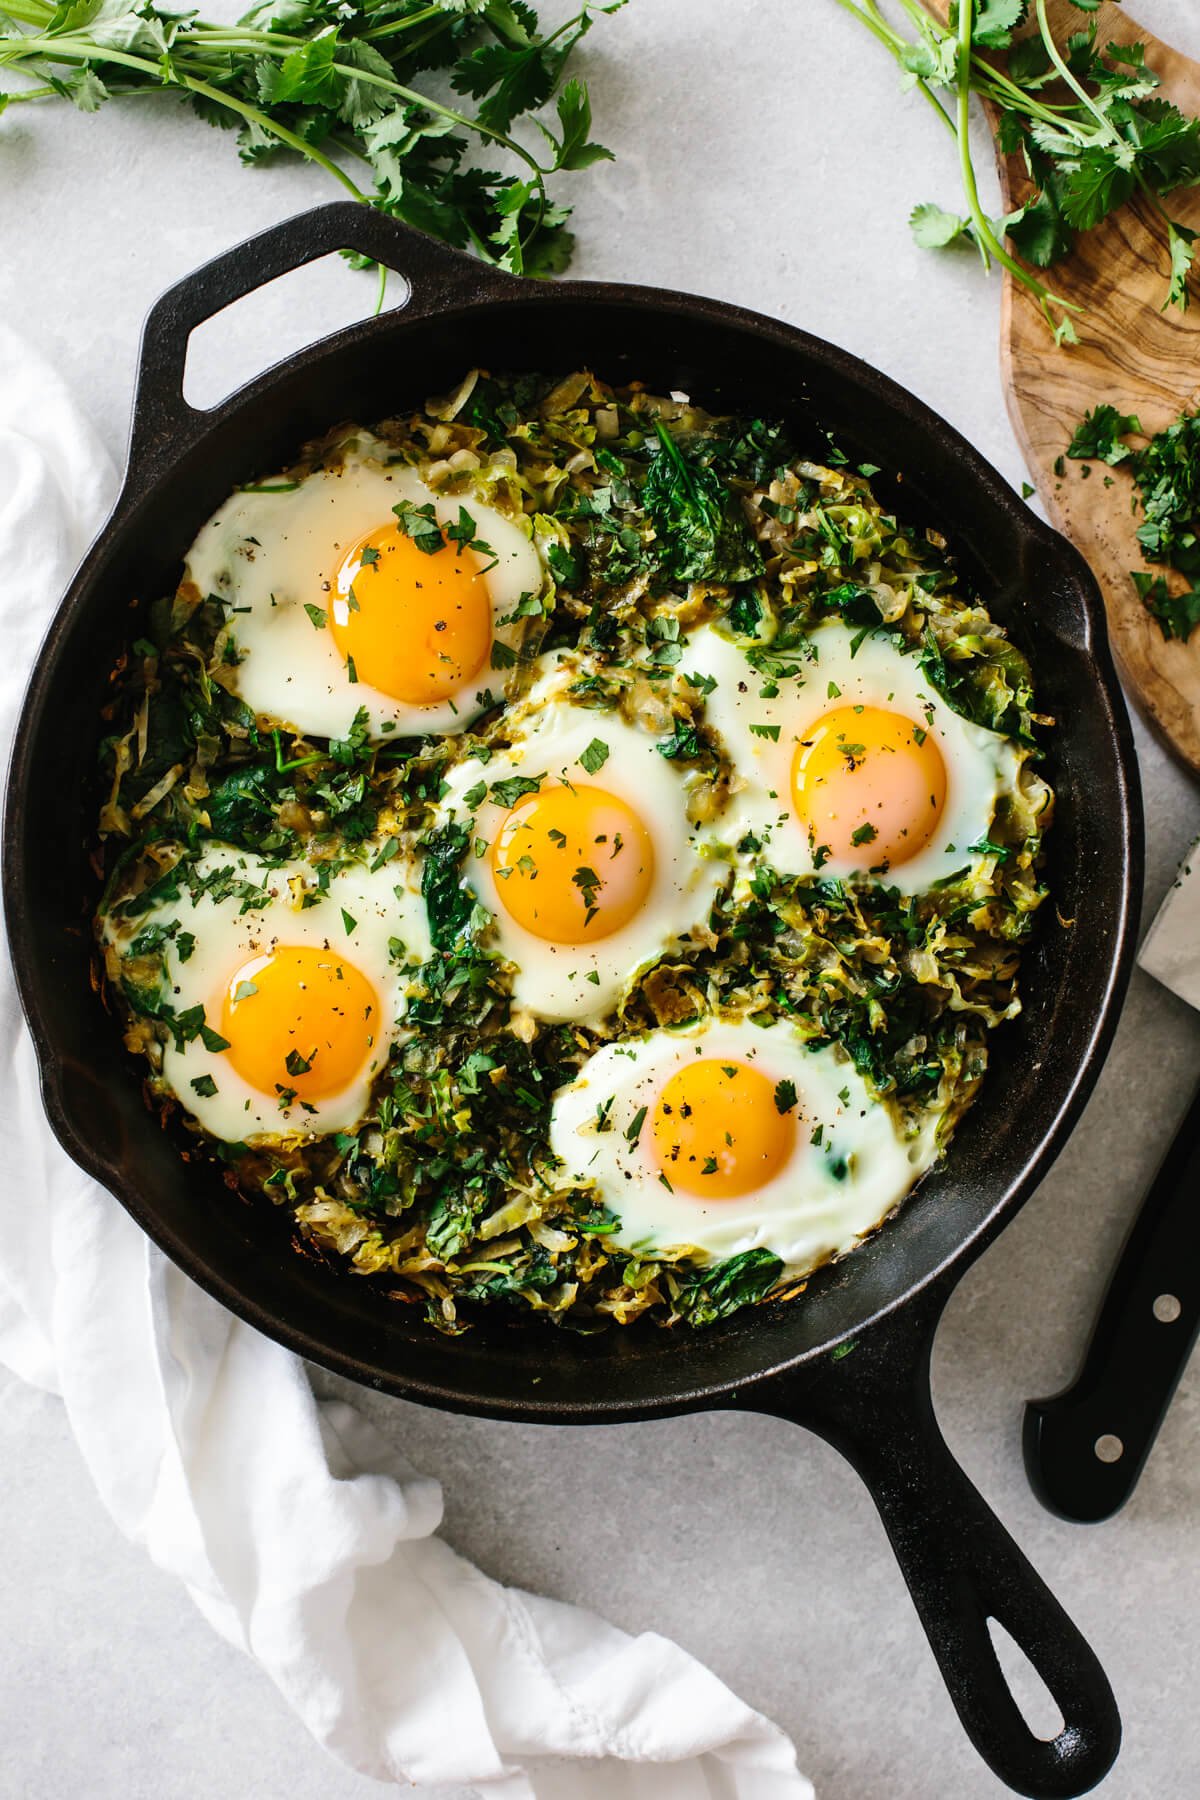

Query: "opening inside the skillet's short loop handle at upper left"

xmin=184 ymin=250 xmax=412 ymax=412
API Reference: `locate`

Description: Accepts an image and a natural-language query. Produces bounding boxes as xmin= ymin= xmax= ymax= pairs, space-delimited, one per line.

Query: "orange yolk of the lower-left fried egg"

xmin=219 ymin=943 xmax=380 ymax=1102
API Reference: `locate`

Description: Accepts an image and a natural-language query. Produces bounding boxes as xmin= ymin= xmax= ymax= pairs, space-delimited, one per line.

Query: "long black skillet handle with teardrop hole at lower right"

xmin=745 ymin=1291 xmax=1121 ymax=1800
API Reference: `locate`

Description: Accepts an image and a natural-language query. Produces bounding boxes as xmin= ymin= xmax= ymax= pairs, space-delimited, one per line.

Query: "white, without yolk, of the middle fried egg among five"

xmin=437 ymin=657 xmax=729 ymax=1019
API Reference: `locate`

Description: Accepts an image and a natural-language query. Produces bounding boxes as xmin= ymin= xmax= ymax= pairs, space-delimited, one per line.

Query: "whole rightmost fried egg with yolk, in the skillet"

xmin=687 ymin=623 xmax=1020 ymax=893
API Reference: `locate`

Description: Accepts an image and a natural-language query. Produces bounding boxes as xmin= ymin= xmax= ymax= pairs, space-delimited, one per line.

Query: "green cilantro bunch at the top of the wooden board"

xmin=838 ymin=0 xmax=1200 ymax=344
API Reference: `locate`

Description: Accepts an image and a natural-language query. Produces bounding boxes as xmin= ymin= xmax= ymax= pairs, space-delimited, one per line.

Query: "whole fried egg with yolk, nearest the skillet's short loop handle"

xmin=184 ymin=434 xmax=543 ymax=738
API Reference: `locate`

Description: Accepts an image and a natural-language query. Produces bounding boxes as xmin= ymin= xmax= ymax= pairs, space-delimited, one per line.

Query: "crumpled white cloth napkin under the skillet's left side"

xmin=0 ymin=326 xmax=813 ymax=1800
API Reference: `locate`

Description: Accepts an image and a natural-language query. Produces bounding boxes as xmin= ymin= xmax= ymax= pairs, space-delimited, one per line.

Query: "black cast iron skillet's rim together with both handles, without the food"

xmin=4 ymin=203 xmax=1141 ymax=1800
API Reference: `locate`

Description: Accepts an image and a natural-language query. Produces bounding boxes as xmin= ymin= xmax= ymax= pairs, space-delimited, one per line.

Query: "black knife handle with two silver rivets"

xmin=1024 ymin=1093 xmax=1200 ymax=1523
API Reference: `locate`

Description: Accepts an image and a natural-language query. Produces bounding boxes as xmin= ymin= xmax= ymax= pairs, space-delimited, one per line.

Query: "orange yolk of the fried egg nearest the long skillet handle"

xmin=642 ymin=1058 xmax=795 ymax=1201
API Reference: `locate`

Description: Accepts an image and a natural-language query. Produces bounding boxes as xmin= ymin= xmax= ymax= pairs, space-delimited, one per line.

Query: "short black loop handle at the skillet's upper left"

xmin=130 ymin=200 xmax=520 ymax=479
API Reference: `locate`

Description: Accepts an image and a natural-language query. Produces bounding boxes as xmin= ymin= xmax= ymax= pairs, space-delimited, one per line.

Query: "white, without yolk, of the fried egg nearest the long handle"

xmin=551 ymin=1019 xmax=937 ymax=1274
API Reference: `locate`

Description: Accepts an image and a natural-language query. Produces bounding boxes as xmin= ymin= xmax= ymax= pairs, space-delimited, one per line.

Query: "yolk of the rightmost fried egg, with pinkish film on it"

xmin=792 ymin=706 xmax=946 ymax=868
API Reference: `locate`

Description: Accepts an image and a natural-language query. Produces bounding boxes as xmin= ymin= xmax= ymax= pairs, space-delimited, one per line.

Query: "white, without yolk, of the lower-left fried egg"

xmin=103 ymin=846 xmax=430 ymax=1143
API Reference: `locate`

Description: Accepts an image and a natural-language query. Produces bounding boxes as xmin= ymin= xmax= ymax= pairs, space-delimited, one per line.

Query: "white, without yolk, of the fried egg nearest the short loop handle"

xmin=184 ymin=432 xmax=545 ymax=738
